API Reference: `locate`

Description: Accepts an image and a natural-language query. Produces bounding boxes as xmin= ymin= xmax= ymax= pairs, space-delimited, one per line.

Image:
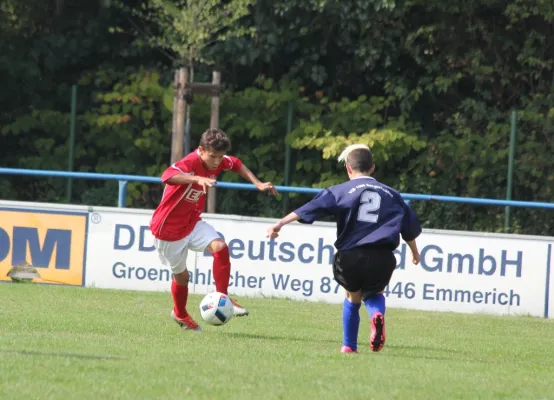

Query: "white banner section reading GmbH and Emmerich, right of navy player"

xmin=387 ymin=232 xmax=551 ymax=316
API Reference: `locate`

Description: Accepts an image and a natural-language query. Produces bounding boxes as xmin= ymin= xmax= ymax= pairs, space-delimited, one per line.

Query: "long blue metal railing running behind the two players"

xmin=0 ymin=168 xmax=554 ymax=209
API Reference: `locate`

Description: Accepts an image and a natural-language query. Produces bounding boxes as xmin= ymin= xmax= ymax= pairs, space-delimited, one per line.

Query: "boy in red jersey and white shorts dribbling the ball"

xmin=150 ymin=129 xmax=277 ymax=331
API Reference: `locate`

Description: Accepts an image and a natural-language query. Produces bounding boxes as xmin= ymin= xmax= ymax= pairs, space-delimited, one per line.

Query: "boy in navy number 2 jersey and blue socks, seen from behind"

xmin=267 ymin=144 xmax=421 ymax=353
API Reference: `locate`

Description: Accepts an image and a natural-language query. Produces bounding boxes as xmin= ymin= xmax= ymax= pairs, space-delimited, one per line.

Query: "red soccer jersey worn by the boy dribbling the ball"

xmin=150 ymin=150 xmax=242 ymax=242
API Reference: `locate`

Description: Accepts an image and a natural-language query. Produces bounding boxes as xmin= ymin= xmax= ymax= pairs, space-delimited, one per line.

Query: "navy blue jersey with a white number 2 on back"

xmin=295 ymin=176 xmax=421 ymax=251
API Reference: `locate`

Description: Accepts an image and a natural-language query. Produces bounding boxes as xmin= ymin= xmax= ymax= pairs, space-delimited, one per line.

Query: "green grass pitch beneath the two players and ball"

xmin=0 ymin=284 xmax=554 ymax=400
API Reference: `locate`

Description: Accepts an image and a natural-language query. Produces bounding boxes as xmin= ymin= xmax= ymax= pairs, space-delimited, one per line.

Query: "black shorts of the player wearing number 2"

xmin=333 ymin=247 xmax=396 ymax=300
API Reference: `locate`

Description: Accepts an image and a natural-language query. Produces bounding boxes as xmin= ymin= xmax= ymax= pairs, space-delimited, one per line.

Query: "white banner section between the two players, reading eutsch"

xmin=192 ymin=218 xmax=336 ymax=302
